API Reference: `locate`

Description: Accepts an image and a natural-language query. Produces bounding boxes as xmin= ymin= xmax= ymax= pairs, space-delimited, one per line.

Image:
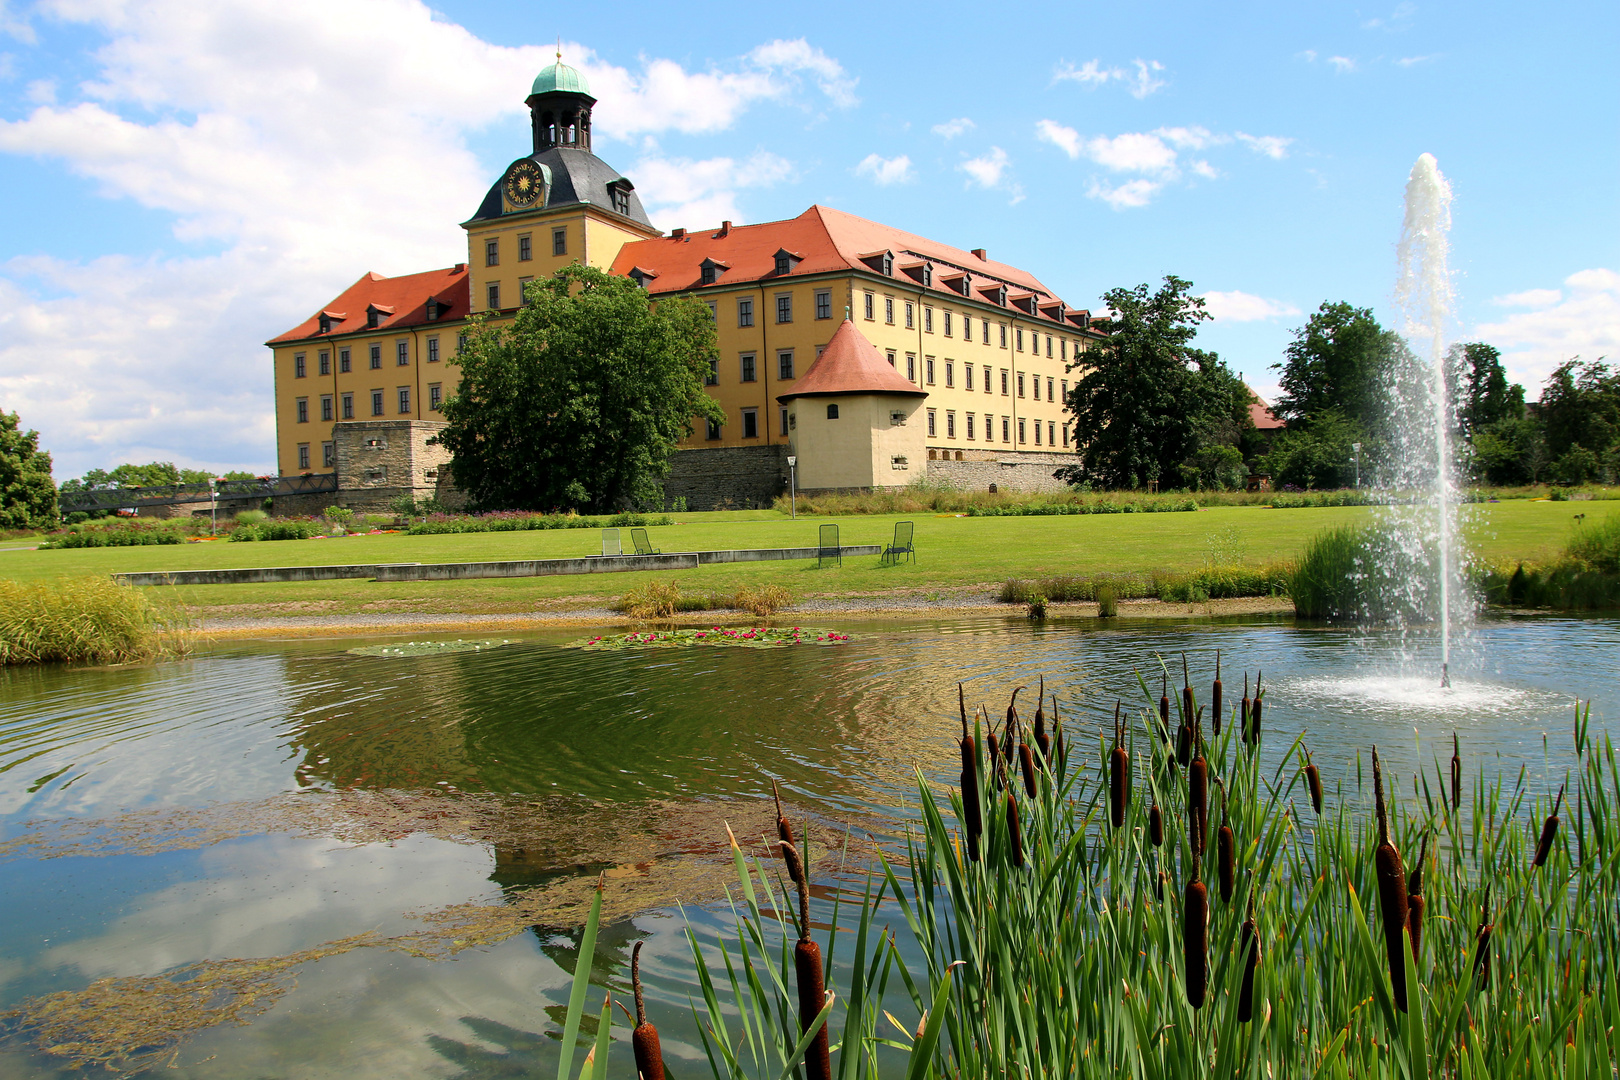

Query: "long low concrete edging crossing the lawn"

xmin=112 ymin=544 xmax=883 ymax=586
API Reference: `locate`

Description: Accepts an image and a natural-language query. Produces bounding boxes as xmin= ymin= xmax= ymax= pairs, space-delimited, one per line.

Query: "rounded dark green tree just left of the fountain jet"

xmin=1272 ymin=303 xmax=1406 ymax=432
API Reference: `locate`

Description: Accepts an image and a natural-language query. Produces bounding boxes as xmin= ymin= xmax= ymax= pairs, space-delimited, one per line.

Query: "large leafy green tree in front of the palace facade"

xmin=437 ymin=264 xmax=724 ymax=512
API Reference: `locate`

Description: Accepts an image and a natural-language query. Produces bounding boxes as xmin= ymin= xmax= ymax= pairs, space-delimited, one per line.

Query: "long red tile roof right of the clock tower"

xmin=612 ymin=206 xmax=1101 ymax=329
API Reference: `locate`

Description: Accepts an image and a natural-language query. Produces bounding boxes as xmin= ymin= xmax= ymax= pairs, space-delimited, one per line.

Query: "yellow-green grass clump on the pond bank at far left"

xmin=0 ymin=578 xmax=193 ymax=665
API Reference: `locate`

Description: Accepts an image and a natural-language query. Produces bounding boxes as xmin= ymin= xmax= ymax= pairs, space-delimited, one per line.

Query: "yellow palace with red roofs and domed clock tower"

xmin=267 ymin=60 xmax=1098 ymax=508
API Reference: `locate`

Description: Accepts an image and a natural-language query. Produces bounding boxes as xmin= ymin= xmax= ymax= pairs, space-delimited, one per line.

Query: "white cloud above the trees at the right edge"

xmin=1469 ymin=269 xmax=1620 ymax=398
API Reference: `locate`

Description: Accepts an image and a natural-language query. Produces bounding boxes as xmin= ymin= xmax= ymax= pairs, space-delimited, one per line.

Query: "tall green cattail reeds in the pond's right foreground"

xmin=654 ymin=667 xmax=1620 ymax=1080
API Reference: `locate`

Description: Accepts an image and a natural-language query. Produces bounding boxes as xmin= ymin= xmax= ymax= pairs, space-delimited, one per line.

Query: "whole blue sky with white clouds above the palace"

xmin=0 ymin=0 xmax=1620 ymax=478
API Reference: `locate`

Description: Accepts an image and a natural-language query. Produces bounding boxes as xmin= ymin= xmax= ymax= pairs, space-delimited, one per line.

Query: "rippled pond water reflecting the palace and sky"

xmin=0 ymin=617 xmax=1620 ymax=1077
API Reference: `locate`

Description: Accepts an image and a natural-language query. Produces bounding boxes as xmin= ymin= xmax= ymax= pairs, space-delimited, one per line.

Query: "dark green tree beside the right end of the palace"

xmin=1058 ymin=275 xmax=1252 ymax=487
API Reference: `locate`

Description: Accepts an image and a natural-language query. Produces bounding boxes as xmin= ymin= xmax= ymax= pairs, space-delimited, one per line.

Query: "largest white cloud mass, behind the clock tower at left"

xmin=0 ymin=0 xmax=854 ymax=478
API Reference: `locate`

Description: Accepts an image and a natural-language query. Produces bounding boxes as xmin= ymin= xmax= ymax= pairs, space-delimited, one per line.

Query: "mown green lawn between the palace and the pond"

xmin=0 ymin=502 xmax=1620 ymax=615
